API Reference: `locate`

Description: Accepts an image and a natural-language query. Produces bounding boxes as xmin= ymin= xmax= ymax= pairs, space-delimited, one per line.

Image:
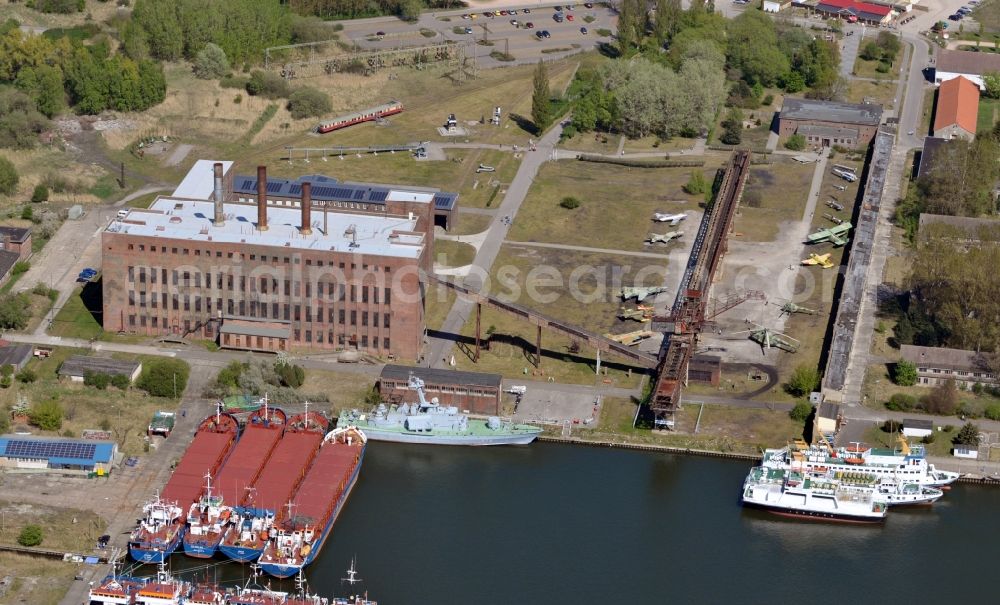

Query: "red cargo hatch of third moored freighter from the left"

xmin=245 ymin=432 xmax=323 ymax=513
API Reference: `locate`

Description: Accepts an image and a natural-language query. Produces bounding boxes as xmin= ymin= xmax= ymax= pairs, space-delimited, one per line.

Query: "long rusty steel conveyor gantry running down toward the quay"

xmin=649 ymin=150 xmax=756 ymax=429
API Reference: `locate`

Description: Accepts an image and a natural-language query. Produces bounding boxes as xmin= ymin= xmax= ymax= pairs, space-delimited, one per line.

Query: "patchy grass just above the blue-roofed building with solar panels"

xmin=0 ymin=347 xmax=183 ymax=456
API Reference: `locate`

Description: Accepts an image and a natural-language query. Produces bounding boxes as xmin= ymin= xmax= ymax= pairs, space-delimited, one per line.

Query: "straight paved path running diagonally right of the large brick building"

xmin=424 ymin=123 xmax=562 ymax=367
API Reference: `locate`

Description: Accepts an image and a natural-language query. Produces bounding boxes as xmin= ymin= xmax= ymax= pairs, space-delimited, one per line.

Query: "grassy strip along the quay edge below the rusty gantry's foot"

xmin=574 ymin=398 xmax=803 ymax=454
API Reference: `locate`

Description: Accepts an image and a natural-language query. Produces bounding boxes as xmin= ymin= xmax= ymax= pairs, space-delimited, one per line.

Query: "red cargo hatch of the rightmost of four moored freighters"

xmin=286 ymin=440 xmax=361 ymax=523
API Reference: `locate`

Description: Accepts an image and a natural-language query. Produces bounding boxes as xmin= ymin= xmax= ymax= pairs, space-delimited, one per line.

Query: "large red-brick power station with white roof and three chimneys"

xmin=102 ymin=160 xmax=455 ymax=360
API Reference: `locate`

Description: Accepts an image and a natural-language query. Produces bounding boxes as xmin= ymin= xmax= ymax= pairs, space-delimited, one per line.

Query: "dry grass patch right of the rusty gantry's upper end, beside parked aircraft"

xmin=733 ymin=157 xmax=815 ymax=242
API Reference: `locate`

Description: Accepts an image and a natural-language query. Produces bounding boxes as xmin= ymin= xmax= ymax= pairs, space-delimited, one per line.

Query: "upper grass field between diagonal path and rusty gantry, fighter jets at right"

xmin=507 ymin=156 xmax=723 ymax=253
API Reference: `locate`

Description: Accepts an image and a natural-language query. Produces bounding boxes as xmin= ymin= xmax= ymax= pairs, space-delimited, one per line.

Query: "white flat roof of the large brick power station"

xmin=106 ymin=196 xmax=425 ymax=258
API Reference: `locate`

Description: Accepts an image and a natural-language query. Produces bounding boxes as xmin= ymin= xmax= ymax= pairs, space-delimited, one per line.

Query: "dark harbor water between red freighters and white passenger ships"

xmin=174 ymin=442 xmax=1000 ymax=605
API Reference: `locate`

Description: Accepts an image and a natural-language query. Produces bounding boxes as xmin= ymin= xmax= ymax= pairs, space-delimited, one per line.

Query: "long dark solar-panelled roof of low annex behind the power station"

xmin=233 ymin=174 xmax=458 ymax=210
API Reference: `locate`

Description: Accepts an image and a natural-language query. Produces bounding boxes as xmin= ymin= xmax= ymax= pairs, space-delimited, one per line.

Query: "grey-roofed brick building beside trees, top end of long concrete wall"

xmin=778 ymin=98 xmax=882 ymax=148
